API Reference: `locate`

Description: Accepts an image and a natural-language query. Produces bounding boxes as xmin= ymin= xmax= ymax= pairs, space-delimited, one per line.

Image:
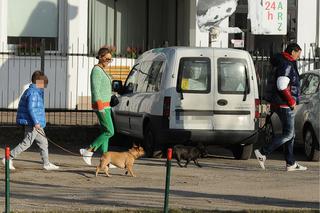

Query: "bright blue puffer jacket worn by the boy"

xmin=17 ymin=84 xmax=46 ymax=128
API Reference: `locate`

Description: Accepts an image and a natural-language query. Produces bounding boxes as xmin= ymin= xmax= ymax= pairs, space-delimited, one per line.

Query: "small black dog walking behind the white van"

xmin=173 ymin=144 xmax=208 ymax=167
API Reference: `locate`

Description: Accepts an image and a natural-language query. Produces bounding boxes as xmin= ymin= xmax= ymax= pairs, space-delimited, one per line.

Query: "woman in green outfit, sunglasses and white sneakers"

xmin=80 ymin=47 xmax=114 ymax=165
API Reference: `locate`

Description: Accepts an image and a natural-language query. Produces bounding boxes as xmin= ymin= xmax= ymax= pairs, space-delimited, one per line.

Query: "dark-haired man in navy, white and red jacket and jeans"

xmin=254 ymin=43 xmax=307 ymax=171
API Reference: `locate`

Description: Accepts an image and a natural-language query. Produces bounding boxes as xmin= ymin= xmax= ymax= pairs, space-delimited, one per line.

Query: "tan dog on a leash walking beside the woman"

xmin=96 ymin=145 xmax=144 ymax=177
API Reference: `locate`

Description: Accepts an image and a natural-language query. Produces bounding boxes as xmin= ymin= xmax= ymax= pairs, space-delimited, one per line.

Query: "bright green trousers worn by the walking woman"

xmin=90 ymin=107 xmax=114 ymax=153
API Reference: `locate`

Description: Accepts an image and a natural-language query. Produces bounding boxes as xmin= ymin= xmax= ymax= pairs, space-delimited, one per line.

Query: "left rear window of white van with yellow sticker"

xmin=177 ymin=57 xmax=211 ymax=93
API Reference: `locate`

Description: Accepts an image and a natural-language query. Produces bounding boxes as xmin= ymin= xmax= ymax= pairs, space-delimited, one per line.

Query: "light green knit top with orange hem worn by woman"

xmin=90 ymin=65 xmax=112 ymax=110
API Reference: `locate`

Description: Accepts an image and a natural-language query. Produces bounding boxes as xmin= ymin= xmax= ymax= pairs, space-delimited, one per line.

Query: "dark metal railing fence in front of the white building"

xmin=0 ymin=43 xmax=320 ymax=126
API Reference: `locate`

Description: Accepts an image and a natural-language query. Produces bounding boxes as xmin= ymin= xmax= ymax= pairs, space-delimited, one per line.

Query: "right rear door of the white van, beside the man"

xmin=213 ymin=54 xmax=256 ymax=130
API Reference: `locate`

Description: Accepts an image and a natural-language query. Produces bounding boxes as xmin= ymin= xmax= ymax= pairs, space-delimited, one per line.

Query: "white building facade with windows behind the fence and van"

xmin=0 ymin=0 xmax=320 ymax=109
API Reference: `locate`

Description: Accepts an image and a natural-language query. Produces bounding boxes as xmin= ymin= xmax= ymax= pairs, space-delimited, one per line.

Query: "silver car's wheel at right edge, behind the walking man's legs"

xmin=303 ymin=127 xmax=320 ymax=161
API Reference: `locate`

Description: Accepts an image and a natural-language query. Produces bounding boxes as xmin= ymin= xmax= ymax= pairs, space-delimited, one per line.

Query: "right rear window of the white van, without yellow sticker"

xmin=218 ymin=58 xmax=250 ymax=94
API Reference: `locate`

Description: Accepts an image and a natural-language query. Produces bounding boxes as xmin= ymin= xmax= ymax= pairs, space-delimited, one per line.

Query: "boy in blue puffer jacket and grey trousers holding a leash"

xmin=2 ymin=71 xmax=59 ymax=170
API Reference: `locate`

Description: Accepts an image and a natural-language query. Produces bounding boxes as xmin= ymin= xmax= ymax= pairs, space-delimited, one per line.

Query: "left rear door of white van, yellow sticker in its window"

xmin=169 ymin=55 xmax=214 ymax=130
